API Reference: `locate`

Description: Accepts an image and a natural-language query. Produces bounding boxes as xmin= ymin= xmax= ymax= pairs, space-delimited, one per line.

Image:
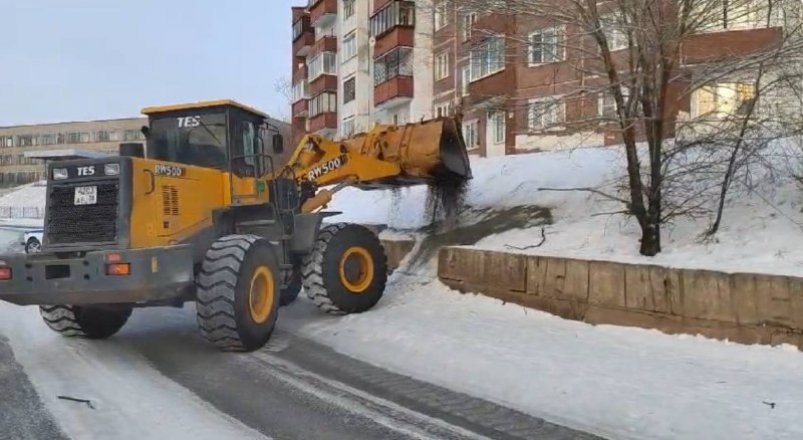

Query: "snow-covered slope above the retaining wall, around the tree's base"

xmin=332 ymin=144 xmax=803 ymax=275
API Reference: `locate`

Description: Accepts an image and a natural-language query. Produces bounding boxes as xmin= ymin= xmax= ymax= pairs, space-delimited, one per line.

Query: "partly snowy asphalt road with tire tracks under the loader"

xmin=0 ymin=304 xmax=596 ymax=440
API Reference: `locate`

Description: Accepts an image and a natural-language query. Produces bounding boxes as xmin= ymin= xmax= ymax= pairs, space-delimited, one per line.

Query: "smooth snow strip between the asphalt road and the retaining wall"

xmin=279 ymin=272 xmax=803 ymax=440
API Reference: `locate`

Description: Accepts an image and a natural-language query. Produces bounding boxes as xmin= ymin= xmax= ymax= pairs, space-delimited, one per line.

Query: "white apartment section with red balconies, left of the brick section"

xmin=292 ymin=0 xmax=433 ymax=145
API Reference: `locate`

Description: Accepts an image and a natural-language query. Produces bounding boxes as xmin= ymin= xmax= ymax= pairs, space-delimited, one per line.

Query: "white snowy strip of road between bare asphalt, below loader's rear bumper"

xmin=0 ymin=303 xmax=264 ymax=440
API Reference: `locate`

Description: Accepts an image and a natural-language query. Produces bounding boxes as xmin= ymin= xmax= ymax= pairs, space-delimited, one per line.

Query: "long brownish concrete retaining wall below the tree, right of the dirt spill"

xmin=438 ymin=247 xmax=803 ymax=348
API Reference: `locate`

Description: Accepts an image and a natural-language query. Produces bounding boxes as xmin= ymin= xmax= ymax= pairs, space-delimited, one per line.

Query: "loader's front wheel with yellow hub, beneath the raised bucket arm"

xmin=301 ymin=223 xmax=388 ymax=315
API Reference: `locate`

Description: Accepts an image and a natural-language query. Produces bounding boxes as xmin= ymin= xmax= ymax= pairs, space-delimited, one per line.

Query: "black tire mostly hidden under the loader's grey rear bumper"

xmin=39 ymin=306 xmax=131 ymax=339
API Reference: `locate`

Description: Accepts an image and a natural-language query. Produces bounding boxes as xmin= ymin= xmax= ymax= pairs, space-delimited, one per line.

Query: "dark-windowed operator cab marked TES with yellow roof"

xmin=140 ymin=100 xmax=284 ymax=177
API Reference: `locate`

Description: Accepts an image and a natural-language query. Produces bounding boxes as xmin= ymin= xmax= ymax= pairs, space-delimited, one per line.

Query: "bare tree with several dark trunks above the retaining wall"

xmin=440 ymin=0 xmax=803 ymax=256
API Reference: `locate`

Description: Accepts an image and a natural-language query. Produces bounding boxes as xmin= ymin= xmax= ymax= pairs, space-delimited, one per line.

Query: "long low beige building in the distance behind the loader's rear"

xmin=0 ymin=118 xmax=148 ymax=186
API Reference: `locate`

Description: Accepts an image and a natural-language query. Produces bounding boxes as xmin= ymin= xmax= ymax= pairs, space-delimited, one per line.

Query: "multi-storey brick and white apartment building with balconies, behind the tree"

xmin=292 ymin=0 xmax=783 ymax=156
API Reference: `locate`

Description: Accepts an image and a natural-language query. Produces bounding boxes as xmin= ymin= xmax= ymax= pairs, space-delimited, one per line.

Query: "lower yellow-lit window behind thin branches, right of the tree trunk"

xmin=693 ymin=82 xmax=756 ymax=118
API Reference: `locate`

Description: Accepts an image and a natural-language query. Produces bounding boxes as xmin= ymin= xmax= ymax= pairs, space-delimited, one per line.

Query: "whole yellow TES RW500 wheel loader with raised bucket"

xmin=0 ymin=100 xmax=471 ymax=351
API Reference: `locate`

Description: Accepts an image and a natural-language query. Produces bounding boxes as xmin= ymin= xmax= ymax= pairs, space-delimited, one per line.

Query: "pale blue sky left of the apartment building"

xmin=0 ymin=0 xmax=306 ymax=126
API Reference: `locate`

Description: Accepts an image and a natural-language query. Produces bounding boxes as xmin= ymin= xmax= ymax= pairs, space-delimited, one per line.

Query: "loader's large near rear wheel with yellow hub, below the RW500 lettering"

xmin=196 ymin=235 xmax=281 ymax=351
